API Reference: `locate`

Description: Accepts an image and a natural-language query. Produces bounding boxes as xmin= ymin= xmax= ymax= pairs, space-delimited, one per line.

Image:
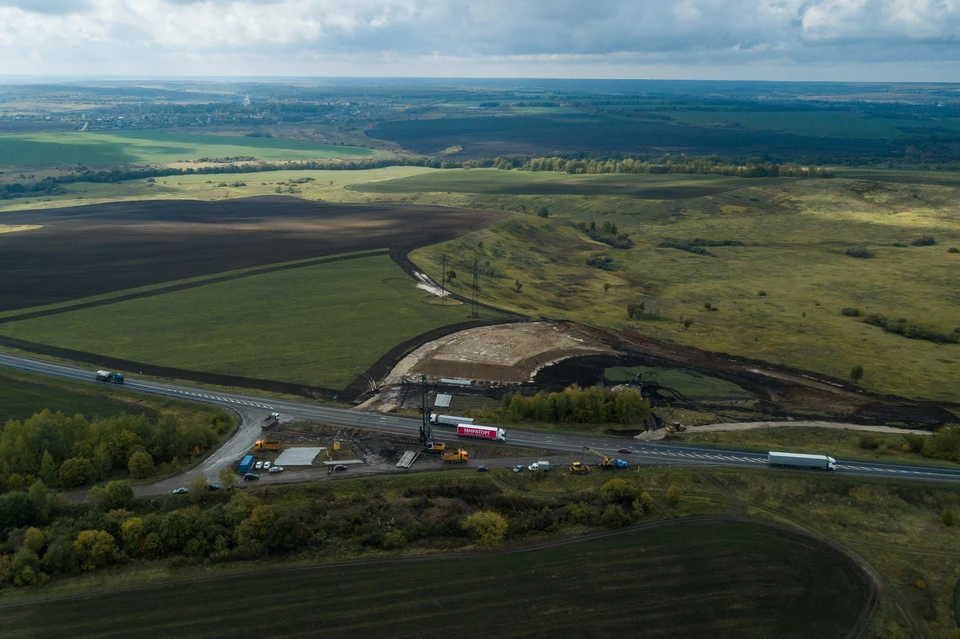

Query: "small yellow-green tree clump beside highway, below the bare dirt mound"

xmin=501 ymin=384 xmax=650 ymax=424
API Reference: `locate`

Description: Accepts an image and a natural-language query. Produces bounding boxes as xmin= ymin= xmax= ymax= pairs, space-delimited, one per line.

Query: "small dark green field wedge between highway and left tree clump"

xmin=0 ymin=375 xmax=135 ymax=424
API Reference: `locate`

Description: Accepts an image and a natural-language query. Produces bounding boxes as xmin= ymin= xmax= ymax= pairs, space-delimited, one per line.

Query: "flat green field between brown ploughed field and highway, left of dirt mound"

xmin=0 ymin=256 xmax=496 ymax=388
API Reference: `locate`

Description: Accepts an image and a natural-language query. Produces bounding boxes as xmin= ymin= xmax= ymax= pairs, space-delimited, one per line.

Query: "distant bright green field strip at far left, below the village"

xmin=0 ymin=131 xmax=380 ymax=166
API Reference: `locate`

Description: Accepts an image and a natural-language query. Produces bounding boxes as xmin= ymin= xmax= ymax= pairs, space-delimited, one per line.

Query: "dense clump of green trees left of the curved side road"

xmin=0 ymin=410 xmax=233 ymax=492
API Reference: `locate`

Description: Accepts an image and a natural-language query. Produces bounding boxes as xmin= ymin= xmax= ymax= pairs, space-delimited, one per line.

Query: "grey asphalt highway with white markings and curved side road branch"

xmin=0 ymin=353 xmax=960 ymax=495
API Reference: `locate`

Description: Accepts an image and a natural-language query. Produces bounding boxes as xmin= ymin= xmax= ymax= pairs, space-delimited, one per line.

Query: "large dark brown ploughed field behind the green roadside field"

xmin=0 ymin=197 xmax=504 ymax=311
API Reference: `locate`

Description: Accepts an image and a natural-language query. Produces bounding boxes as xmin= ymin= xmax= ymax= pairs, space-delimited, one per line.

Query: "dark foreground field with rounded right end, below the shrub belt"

xmin=4 ymin=521 xmax=868 ymax=639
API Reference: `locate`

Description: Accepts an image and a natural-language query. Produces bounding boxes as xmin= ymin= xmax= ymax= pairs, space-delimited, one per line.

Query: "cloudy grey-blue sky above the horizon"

xmin=0 ymin=0 xmax=960 ymax=81
